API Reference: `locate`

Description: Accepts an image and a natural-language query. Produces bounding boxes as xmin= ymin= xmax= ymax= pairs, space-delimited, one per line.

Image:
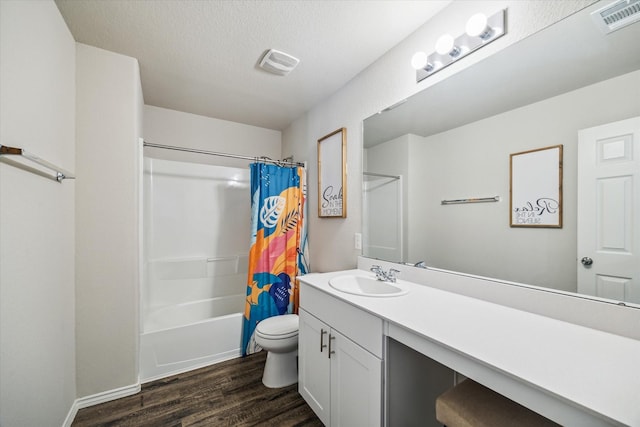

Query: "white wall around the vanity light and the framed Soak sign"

xmin=283 ymin=0 xmax=593 ymax=271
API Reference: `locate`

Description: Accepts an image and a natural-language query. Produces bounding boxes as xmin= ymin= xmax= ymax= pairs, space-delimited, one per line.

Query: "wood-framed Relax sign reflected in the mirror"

xmin=509 ymin=145 xmax=562 ymax=228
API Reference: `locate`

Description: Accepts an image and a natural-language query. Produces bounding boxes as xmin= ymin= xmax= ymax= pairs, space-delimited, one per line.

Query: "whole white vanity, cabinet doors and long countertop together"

xmin=299 ymin=268 xmax=640 ymax=427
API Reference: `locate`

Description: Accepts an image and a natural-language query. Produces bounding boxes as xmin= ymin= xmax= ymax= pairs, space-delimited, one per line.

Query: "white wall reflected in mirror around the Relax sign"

xmin=409 ymin=71 xmax=640 ymax=292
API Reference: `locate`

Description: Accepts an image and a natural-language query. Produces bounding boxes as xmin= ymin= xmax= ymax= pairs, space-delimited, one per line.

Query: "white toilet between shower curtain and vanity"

xmin=255 ymin=314 xmax=298 ymax=388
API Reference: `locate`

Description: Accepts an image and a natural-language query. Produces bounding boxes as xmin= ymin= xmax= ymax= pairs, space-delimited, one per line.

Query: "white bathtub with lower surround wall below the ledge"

xmin=140 ymin=255 xmax=248 ymax=382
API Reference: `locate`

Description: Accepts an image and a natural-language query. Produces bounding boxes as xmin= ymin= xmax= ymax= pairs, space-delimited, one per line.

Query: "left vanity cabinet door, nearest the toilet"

xmin=298 ymin=309 xmax=331 ymax=426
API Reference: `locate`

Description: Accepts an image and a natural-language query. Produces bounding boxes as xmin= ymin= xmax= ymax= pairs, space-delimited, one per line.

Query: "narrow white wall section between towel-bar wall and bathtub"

xmin=76 ymin=44 xmax=143 ymax=397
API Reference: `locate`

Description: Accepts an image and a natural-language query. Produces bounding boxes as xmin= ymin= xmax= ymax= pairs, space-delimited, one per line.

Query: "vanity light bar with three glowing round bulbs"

xmin=411 ymin=9 xmax=506 ymax=83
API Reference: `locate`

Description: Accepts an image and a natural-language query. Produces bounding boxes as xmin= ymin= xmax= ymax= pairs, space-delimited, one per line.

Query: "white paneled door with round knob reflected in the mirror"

xmin=577 ymin=117 xmax=640 ymax=303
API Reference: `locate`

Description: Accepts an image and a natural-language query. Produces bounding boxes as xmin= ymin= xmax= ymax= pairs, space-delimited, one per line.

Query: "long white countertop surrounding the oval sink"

xmin=299 ymin=270 xmax=640 ymax=426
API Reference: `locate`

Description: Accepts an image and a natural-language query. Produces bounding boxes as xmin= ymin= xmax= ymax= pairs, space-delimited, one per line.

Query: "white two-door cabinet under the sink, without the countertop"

xmin=298 ymin=285 xmax=383 ymax=427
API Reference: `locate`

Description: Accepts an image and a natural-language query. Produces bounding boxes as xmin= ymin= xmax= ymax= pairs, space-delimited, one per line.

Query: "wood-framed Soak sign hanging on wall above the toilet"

xmin=318 ymin=128 xmax=347 ymax=218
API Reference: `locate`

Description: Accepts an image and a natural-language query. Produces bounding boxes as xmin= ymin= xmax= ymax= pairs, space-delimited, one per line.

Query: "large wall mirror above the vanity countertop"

xmin=363 ymin=1 xmax=640 ymax=303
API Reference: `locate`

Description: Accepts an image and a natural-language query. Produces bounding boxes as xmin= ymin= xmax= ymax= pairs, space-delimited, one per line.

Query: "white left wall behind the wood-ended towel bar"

xmin=0 ymin=0 xmax=76 ymax=427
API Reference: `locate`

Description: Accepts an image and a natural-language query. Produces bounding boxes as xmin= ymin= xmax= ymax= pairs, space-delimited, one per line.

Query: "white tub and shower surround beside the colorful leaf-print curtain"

xmin=140 ymin=156 xmax=251 ymax=382
